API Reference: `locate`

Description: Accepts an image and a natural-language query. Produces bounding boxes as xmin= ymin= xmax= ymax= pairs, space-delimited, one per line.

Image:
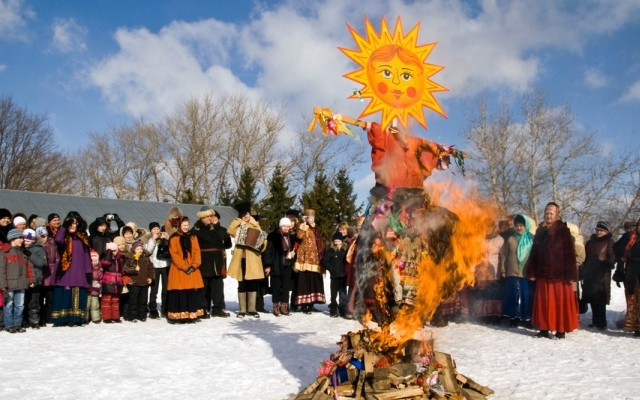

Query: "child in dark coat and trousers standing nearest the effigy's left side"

xmin=323 ymin=232 xmax=347 ymax=318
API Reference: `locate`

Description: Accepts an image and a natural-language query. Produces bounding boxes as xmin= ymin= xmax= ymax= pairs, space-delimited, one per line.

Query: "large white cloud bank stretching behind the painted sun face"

xmin=85 ymin=0 xmax=640 ymax=130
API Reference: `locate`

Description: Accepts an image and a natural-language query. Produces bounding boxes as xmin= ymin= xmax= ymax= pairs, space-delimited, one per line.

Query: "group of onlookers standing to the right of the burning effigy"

xmin=462 ymin=202 xmax=640 ymax=339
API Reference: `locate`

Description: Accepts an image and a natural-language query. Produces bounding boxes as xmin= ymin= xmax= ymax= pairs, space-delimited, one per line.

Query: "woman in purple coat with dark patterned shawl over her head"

xmin=51 ymin=211 xmax=93 ymax=326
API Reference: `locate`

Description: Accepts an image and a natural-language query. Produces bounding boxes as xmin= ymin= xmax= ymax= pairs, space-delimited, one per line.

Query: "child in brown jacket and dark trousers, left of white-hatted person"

xmin=124 ymin=241 xmax=154 ymax=322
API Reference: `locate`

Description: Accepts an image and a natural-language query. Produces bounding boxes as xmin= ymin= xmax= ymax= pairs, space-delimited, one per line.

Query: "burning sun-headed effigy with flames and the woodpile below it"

xmin=295 ymin=17 xmax=496 ymax=399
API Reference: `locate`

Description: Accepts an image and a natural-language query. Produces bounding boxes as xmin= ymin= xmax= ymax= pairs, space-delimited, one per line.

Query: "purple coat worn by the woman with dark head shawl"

xmin=51 ymin=226 xmax=93 ymax=289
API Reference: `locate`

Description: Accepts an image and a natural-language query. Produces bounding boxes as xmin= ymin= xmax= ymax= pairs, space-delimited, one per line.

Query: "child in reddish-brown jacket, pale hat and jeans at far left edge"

xmin=0 ymin=229 xmax=34 ymax=333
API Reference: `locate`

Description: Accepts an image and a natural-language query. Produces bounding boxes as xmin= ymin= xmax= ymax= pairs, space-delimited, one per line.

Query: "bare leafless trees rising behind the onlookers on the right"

xmin=466 ymin=91 xmax=639 ymax=228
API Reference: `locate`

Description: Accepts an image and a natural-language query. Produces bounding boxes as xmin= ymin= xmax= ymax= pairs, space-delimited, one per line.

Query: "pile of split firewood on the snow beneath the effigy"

xmin=289 ymin=330 xmax=493 ymax=400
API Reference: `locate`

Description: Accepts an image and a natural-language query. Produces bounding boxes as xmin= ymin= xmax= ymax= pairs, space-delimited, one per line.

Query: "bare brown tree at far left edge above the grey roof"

xmin=0 ymin=96 xmax=73 ymax=193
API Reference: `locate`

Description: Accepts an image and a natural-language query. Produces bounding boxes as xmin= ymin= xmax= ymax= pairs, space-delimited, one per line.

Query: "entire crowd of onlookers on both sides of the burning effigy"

xmin=0 ymin=202 xmax=640 ymax=339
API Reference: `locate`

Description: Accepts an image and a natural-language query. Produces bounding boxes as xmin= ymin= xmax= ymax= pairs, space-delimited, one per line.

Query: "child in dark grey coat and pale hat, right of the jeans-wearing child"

xmin=22 ymin=229 xmax=47 ymax=329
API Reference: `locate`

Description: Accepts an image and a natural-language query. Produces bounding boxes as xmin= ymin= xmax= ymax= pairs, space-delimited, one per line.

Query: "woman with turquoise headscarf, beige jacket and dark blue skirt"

xmin=499 ymin=214 xmax=534 ymax=327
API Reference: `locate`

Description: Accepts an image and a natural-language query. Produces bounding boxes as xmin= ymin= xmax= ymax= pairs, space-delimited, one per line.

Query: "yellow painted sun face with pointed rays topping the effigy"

xmin=339 ymin=17 xmax=449 ymax=129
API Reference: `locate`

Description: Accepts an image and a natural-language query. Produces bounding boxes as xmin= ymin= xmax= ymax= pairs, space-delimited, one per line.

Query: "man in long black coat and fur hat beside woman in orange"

xmin=191 ymin=206 xmax=232 ymax=318
